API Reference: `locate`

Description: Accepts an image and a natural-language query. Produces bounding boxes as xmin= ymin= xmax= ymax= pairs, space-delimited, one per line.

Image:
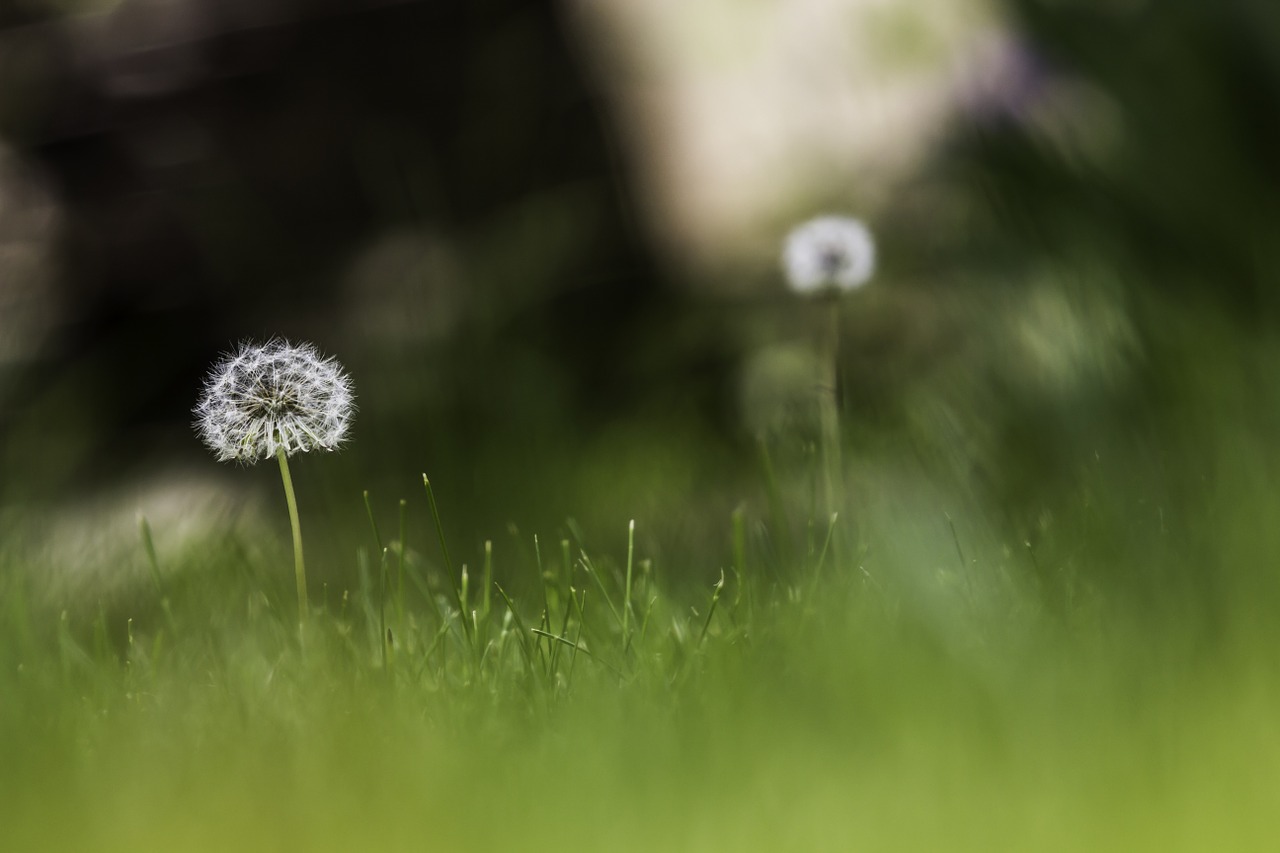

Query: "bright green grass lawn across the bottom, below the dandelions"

xmin=0 ymin=445 xmax=1280 ymax=850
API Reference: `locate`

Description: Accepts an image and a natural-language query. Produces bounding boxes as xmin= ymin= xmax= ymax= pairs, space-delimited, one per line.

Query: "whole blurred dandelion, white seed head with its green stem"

xmin=782 ymin=216 xmax=876 ymax=516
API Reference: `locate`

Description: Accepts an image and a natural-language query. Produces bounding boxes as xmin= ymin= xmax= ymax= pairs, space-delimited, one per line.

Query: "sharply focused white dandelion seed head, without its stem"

xmin=195 ymin=339 xmax=355 ymax=465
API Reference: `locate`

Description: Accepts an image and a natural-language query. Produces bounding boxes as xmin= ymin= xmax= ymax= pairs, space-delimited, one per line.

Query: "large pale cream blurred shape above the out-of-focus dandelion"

xmin=567 ymin=0 xmax=996 ymax=279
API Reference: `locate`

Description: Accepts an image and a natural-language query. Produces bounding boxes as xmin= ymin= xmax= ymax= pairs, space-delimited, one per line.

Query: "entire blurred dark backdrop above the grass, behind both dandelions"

xmin=0 ymin=0 xmax=1280 ymax=622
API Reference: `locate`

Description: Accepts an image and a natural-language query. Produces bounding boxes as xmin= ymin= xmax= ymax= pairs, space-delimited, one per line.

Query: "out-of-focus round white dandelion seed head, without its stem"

xmin=782 ymin=216 xmax=876 ymax=293
